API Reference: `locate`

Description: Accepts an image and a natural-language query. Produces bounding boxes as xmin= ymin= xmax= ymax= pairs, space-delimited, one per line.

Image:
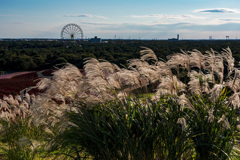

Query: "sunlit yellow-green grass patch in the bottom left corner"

xmin=0 ymin=119 xmax=51 ymax=160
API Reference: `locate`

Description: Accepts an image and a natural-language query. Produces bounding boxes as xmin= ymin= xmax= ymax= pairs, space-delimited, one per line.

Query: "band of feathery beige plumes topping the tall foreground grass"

xmin=1 ymin=47 xmax=240 ymax=127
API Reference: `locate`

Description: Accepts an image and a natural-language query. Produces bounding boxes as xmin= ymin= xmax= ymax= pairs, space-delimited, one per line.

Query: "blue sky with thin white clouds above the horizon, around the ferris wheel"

xmin=0 ymin=0 xmax=240 ymax=39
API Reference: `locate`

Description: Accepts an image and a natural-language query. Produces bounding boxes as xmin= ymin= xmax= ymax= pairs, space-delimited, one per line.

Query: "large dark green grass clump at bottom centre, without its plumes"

xmin=49 ymin=97 xmax=192 ymax=160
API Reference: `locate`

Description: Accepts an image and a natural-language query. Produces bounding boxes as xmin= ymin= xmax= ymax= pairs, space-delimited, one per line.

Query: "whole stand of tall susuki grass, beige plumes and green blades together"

xmin=0 ymin=47 xmax=240 ymax=160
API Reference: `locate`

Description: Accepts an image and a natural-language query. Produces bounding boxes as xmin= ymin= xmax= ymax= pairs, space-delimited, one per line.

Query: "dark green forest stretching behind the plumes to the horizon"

xmin=0 ymin=40 xmax=240 ymax=71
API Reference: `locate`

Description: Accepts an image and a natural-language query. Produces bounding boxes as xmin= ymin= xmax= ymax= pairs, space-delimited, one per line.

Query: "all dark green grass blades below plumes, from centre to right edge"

xmin=49 ymin=92 xmax=239 ymax=160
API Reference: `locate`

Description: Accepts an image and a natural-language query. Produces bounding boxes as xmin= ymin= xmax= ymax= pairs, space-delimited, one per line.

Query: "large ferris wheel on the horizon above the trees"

xmin=61 ymin=23 xmax=83 ymax=40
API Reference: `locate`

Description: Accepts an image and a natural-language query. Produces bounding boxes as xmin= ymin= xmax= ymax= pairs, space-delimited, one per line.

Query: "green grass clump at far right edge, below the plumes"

xmin=185 ymin=90 xmax=239 ymax=160
